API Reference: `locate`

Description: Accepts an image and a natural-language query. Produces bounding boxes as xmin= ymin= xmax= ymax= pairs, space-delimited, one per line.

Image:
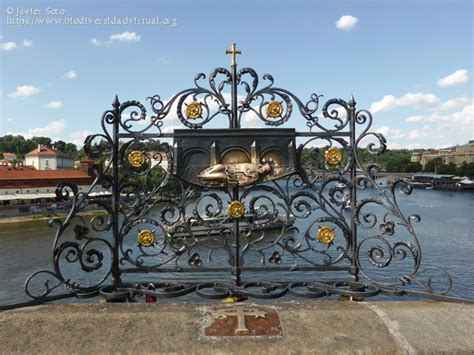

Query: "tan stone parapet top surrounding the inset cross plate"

xmin=0 ymin=301 xmax=474 ymax=354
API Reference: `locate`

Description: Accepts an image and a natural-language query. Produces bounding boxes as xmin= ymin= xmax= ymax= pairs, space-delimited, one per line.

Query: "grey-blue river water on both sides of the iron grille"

xmin=0 ymin=190 xmax=474 ymax=304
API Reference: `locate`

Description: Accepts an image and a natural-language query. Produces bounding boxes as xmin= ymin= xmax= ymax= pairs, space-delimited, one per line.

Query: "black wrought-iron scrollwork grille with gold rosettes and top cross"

xmin=1 ymin=45 xmax=464 ymax=309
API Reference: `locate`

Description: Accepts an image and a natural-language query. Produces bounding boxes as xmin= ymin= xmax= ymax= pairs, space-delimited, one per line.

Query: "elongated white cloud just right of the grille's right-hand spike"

xmin=370 ymin=92 xmax=439 ymax=113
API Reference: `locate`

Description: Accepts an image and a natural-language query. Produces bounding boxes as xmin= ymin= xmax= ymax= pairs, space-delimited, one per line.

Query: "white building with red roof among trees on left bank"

xmin=25 ymin=144 xmax=74 ymax=170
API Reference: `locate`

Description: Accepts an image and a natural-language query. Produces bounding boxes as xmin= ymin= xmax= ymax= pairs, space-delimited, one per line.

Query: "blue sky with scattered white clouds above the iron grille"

xmin=0 ymin=0 xmax=474 ymax=149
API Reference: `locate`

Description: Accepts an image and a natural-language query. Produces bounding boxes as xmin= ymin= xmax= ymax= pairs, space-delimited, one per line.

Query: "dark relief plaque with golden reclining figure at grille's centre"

xmin=174 ymin=128 xmax=296 ymax=188
